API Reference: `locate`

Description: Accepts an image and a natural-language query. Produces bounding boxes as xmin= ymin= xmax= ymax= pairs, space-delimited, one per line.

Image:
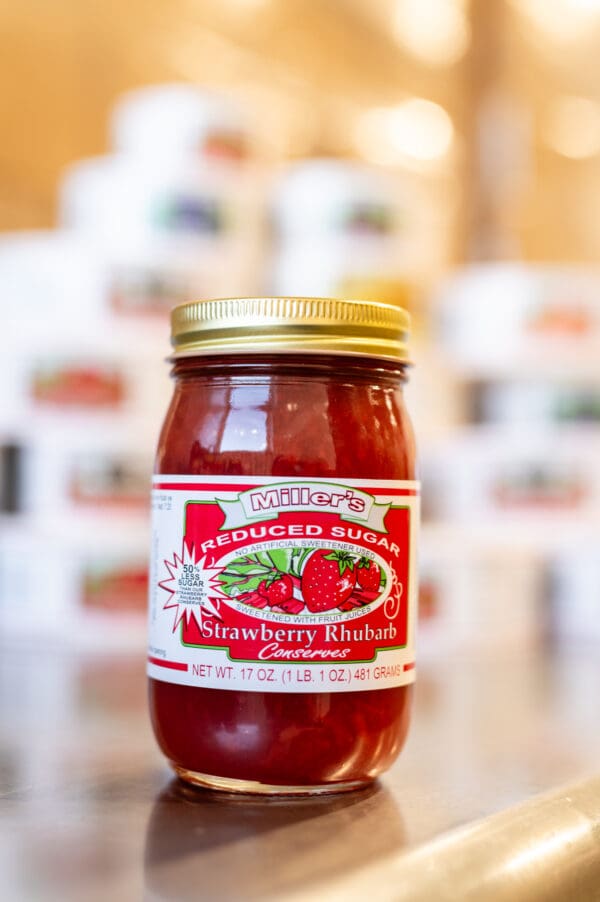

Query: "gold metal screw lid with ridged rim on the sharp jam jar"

xmin=171 ymin=297 xmax=410 ymax=363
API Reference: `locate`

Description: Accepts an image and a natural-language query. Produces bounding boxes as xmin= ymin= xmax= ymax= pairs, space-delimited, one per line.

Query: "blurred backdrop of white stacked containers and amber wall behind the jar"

xmin=0 ymin=0 xmax=600 ymax=660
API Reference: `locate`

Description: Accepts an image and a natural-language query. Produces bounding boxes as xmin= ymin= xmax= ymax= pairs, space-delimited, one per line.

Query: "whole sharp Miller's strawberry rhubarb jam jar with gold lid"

xmin=148 ymin=298 xmax=418 ymax=794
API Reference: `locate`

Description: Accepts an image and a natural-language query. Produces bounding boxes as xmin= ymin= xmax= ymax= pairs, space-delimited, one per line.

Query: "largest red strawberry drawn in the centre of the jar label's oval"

xmin=302 ymin=548 xmax=356 ymax=613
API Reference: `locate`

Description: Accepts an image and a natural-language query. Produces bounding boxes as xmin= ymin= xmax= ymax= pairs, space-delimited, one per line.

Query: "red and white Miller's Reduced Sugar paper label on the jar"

xmin=148 ymin=475 xmax=419 ymax=692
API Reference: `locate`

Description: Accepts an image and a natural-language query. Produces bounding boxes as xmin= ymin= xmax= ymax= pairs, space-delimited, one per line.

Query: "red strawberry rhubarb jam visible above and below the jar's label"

xmin=150 ymin=353 xmax=415 ymax=792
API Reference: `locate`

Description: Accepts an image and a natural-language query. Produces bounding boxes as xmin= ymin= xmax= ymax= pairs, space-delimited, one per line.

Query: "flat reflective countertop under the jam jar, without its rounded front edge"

xmin=0 ymin=640 xmax=600 ymax=902
